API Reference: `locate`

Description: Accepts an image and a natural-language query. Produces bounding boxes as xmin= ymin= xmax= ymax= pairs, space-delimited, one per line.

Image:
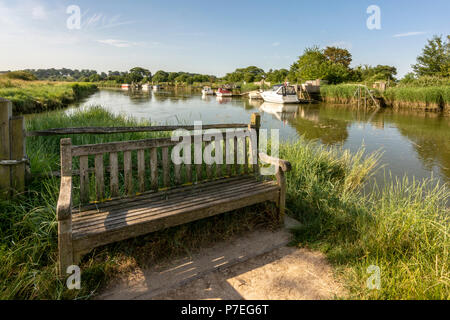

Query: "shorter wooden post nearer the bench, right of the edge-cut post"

xmin=9 ymin=117 xmax=26 ymax=193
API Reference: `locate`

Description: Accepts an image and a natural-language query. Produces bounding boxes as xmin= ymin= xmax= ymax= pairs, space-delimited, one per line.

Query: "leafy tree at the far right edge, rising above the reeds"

xmin=412 ymin=35 xmax=450 ymax=77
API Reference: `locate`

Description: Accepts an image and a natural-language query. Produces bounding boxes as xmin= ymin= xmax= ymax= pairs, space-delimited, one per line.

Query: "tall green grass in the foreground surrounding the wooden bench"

xmin=0 ymin=108 xmax=450 ymax=299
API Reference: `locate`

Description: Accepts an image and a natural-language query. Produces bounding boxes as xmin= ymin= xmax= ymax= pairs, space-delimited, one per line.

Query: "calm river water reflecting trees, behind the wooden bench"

xmin=74 ymin=90 xmax=450 ymax=186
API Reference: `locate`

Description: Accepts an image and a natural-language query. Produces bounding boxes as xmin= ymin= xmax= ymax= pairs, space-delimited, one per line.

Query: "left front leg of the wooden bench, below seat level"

xmin=58 ymin=219 xmax=74 ymax=277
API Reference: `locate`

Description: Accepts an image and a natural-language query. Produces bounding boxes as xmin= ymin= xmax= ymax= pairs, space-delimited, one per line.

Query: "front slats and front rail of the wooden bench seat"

xmin=73 ymin=182 xmax=279 ymax=251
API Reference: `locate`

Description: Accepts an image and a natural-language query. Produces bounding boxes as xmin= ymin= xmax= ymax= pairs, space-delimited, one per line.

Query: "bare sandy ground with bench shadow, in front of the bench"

xmin=97 ymin=219 xmax=345 ymax=300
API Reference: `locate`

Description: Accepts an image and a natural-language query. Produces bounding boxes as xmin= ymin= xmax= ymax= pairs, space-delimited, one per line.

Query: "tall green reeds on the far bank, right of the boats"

xmin=320 ymin=84 xmax=450 ymax=113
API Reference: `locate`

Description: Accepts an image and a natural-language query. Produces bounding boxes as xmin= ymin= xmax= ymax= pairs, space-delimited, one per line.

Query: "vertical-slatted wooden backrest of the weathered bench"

xmin=61 ymin=114 xmax=259 ymax=205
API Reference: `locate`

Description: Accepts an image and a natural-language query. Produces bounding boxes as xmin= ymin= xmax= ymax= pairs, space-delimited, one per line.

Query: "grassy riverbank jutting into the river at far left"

xmin=0 ymin=77 xmax=98 ymax=114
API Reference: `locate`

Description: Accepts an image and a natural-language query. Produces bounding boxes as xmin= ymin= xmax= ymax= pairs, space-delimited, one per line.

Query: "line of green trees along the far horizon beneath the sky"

xmin=8 ymin=36 xmax=450 ymax=84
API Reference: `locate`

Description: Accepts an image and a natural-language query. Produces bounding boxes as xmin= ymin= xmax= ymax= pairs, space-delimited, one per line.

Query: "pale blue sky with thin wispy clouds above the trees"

xmin=0 ymin=0 xmax=450 ymax=76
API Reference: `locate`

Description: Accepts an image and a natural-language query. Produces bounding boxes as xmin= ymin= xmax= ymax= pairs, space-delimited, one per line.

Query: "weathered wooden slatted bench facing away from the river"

xmin=57 ymin=114 xmax=290 ymax=276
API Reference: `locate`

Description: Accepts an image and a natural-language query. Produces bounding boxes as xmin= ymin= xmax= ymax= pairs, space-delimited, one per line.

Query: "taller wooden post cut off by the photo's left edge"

xmin=0 ymin=98 xmax=12 ymax=199
